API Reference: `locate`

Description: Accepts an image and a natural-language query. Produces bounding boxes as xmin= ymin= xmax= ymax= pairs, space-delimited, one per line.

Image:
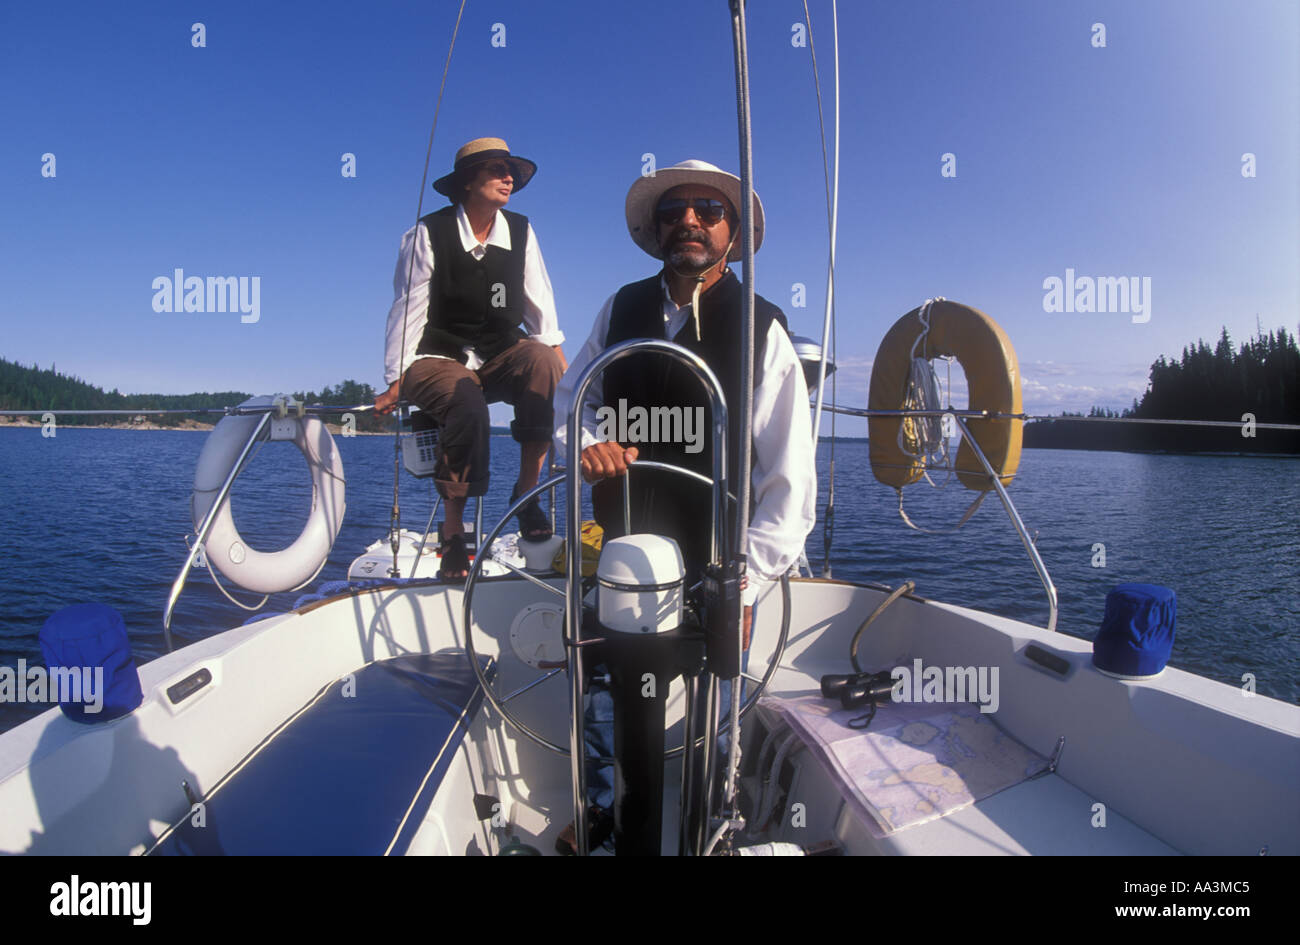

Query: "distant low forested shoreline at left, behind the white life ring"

xmin=0 ymin=357 xmax=391 ymax=433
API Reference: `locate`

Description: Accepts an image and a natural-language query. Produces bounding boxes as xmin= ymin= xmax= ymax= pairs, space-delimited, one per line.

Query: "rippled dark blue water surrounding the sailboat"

xmin=0 ymin=428 xmax=1300 ymax=729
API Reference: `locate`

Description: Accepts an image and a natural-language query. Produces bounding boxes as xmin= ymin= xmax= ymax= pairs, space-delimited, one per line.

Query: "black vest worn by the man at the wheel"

xmin=593 ymin=272 xmax=787 ymax=571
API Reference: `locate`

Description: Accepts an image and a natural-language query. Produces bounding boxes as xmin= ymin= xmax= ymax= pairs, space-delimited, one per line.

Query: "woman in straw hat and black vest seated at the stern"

xmin=374 ymin=138 xmax=566 ymax=581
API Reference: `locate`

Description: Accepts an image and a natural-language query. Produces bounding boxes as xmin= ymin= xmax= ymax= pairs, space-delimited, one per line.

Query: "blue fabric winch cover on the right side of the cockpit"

xmin=1092 ymin=584 xmax=1178 ymax=679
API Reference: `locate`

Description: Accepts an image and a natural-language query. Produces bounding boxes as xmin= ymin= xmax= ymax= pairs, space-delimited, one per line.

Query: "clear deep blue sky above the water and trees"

xmin=0 ymin=0 xmax=1300 ymax=431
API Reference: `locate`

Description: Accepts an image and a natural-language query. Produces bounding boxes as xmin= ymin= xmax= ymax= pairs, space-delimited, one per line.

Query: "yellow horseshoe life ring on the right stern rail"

xmin=867 ymin=299 xmax=1023 ymax=491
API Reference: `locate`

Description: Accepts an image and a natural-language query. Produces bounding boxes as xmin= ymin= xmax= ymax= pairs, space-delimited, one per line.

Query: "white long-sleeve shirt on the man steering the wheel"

xmin=555 ymin=279 xmax=816 ymax=604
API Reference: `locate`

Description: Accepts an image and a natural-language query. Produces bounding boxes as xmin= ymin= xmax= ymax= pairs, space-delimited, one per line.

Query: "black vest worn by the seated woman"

xmin=416 ymin=207 xmax=528 ymax=364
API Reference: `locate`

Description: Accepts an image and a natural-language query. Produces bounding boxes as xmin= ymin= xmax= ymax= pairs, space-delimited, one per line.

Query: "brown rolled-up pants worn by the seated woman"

xmin=402 ymin=338 xmax=564 ymax=499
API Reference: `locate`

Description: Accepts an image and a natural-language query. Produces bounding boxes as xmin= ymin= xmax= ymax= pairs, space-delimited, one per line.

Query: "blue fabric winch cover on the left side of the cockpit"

xmin=40 ymin=603 xmax=144 ymax=725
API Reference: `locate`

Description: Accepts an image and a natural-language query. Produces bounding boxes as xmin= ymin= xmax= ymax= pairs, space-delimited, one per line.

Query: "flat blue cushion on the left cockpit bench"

xmin=150 ymin=650 xmax=495 ymax=857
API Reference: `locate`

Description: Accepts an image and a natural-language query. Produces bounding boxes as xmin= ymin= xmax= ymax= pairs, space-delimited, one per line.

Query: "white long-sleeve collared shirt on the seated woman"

xmin=384 ymin=204 xmax=564 ymax=385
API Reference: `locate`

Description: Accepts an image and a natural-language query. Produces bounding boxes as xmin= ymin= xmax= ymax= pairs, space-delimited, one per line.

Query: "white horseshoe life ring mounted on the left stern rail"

xmin=190 ymin=395 xmax=346 ymax=594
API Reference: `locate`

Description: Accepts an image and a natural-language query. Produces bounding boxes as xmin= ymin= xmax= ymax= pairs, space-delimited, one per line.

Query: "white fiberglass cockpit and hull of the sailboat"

xmin=0 ymin=577 xmax=1300 ymax=854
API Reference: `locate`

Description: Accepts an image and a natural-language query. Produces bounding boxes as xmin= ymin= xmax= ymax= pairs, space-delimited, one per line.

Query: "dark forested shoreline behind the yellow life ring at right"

xmin=1024 ymin=328 xmax=1300 ymax=454
